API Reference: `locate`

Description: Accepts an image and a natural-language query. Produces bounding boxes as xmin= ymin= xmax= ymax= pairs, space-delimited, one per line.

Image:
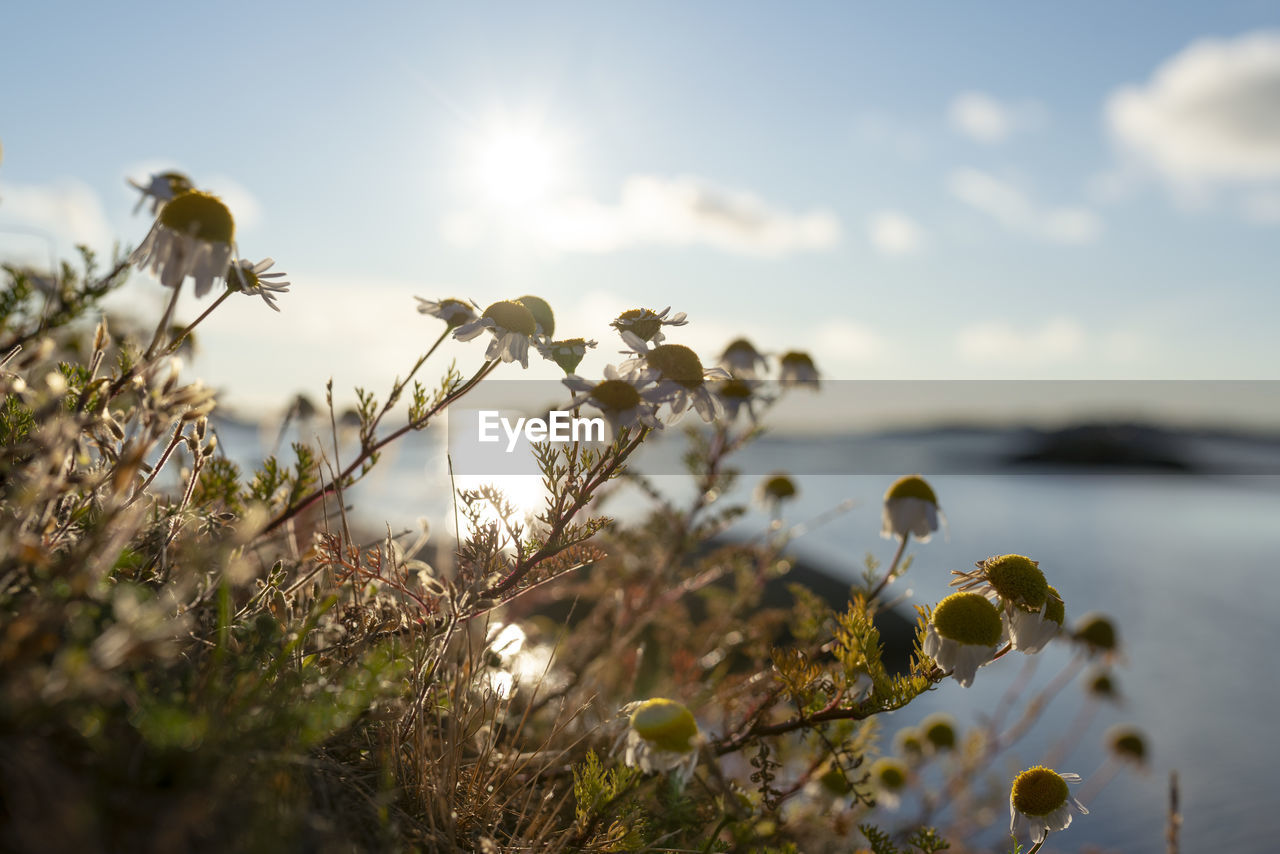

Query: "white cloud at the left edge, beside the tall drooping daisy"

xmin=0 ymin=179 xmax=114 ymax=265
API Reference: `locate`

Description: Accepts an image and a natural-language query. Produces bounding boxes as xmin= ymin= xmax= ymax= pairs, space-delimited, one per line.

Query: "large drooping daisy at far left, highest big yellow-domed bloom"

xmin=129 ymin=189 xmax=236 ymax=297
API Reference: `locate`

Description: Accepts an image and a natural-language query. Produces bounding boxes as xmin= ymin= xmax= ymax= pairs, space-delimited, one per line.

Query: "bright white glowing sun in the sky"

xmin=470 ymin=120 xmax=567 ymax=210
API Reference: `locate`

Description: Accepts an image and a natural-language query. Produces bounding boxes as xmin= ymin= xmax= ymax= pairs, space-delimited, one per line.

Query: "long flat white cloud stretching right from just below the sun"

xmin=442 ymin=175 xmax=840 ymax=256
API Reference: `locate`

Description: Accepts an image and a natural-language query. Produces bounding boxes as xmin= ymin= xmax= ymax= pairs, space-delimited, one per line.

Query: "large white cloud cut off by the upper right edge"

xmin=1106 ymin=32 xmax=1280 ymax=182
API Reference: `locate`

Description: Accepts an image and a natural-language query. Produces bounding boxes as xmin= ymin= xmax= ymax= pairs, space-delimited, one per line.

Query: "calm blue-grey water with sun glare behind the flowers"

xmin=224 ymin=422 xmax=1280 ymax=854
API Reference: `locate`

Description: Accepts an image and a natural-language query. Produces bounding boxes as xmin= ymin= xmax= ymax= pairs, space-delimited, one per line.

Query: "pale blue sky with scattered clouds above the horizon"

xmin=0 ymin=1 xmax=1280 ymax=422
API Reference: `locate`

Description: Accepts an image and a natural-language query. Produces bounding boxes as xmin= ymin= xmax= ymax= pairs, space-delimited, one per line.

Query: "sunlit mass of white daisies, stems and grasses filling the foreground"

xmin=0 ymin=163 xmax=1148 ymax=851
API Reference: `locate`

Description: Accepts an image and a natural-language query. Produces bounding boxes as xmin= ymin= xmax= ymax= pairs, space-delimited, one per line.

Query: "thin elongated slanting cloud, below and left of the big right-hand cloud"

xmin=947 ymin=169 xmax=1102 ymax=246
